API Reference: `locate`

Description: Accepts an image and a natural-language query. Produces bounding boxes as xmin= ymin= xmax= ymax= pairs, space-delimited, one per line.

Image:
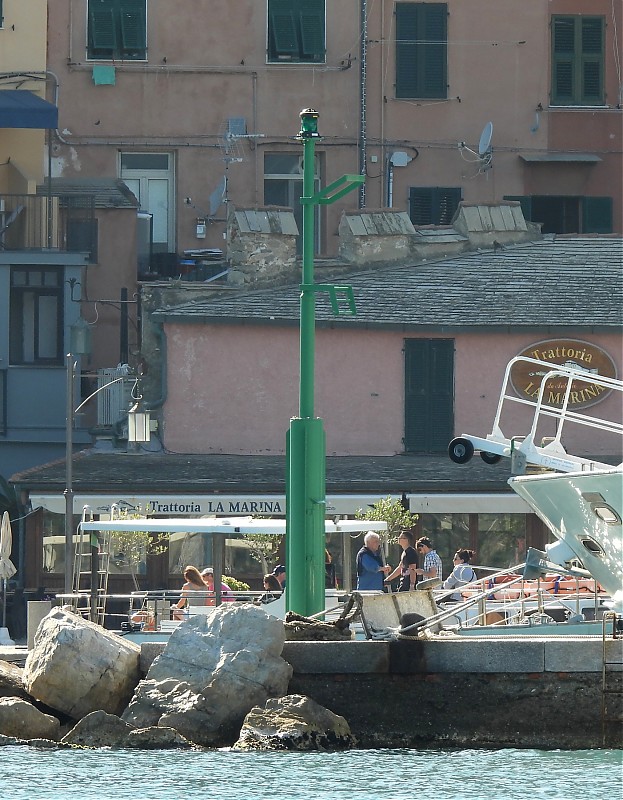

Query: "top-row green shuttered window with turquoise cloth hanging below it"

xmin=87 ymin=0 xmax=147 ymax=61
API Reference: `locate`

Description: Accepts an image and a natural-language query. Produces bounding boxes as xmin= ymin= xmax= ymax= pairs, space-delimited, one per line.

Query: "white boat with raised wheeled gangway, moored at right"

xmin=412 ymin=358 xmax=623 ymax=636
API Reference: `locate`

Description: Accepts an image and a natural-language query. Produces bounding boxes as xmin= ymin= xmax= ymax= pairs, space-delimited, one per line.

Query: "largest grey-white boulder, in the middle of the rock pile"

xmin=122 ymin=604 xmax=292 ymax=746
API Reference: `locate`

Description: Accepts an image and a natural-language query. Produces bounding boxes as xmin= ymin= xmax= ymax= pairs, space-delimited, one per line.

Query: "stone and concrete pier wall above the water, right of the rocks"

xmin=141 ymin=637 xmax=623 ymax=749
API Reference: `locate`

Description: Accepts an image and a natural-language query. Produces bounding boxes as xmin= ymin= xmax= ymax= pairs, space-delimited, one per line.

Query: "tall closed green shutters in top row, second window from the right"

xmin=396 ymin=3 xmax=448 ymax=98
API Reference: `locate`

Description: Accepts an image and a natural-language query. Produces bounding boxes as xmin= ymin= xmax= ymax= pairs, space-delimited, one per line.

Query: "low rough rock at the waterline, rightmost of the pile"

xmin=234 ymin=694 xmax=356 ymax=750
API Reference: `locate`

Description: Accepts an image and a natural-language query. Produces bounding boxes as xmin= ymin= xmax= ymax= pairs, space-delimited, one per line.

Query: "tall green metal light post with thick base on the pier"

xmin=286 ymin=108 xmax=364 ymax=616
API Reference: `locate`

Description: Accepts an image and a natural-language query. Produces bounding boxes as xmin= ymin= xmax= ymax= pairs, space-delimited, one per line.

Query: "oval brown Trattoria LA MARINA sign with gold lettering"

xmin=510 ymin=339 xmax=617 ymax=409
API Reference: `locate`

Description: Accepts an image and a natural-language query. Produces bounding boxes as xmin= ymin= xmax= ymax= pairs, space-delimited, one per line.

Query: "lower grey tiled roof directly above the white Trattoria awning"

xmin=10 ymin=450 xmax=511 ymax=495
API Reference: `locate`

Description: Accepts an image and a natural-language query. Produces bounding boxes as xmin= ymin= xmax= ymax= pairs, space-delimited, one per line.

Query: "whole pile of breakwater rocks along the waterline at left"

xmin=0 ymin=605 xmax=354 ymax=750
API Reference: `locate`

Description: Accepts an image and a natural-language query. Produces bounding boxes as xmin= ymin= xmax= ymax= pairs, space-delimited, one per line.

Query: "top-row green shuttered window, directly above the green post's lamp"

xmin=267 ymin=0 xmax=325 ymax=64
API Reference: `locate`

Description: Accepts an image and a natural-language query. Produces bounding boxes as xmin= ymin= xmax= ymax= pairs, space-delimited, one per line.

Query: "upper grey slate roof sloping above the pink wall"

xmin=154 ymin=237 xmax=623 ymax=332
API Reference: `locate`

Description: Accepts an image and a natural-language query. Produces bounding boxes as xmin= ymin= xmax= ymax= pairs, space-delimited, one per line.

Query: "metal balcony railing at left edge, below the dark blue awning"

xmin=0 ymin=194 xmax=97 ymax=262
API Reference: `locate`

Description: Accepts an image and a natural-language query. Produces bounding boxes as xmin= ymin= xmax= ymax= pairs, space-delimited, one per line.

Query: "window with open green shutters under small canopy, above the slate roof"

xmin=504 ymin=195 xmax=613 ymax=233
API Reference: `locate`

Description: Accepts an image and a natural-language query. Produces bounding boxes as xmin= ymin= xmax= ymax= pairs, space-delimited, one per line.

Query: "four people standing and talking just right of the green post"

xmin=357 ymin=531 xmax=477 ymax=600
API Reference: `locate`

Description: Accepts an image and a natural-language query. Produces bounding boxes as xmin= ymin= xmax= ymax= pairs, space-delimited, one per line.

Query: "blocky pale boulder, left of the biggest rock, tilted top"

xmin=23 ymin=608 xmax=141 ymax=719
